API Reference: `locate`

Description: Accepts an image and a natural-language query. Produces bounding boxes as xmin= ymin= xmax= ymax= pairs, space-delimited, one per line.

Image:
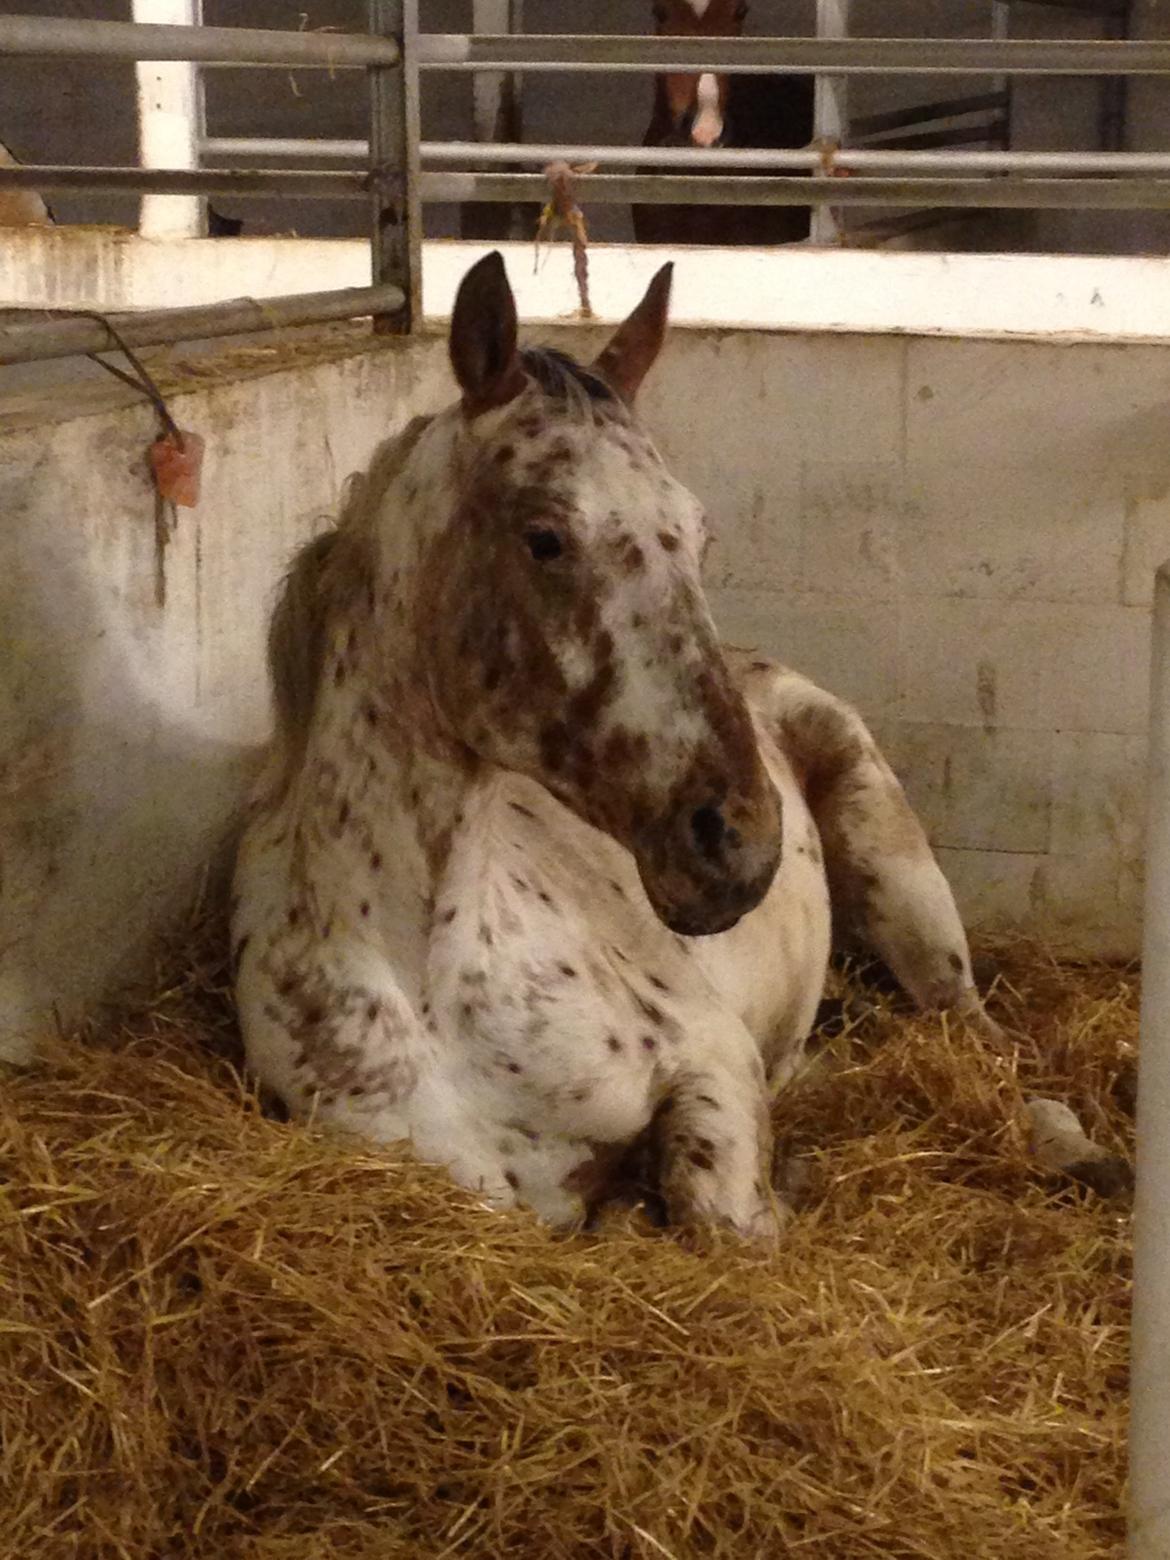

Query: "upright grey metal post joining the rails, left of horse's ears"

xmin=368 ymin=0 xmax=423 ymax=335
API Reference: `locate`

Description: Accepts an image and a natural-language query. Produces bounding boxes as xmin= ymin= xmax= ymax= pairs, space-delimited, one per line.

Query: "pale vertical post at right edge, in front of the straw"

xmin=1129 ymin=563 xmax=1170 ymax=1560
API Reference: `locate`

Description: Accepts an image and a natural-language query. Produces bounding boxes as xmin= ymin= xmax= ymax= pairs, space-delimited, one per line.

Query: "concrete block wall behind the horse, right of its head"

xmin=647 ymin=334 xmax=1170 ymax=955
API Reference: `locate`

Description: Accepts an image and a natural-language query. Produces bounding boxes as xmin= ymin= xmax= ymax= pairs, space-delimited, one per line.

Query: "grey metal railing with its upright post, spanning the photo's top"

xmin=0 ymin=9 xmax=1170 ymax=357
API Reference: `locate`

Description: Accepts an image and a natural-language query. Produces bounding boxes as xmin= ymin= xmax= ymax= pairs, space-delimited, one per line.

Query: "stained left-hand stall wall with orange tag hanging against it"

xmin=0 ymin=335 xmax=464 ymax=1056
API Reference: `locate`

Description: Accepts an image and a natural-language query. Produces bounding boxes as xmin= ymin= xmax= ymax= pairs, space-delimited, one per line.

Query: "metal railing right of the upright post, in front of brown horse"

xmin=163 ymin=13 xmax=1170 ymax=227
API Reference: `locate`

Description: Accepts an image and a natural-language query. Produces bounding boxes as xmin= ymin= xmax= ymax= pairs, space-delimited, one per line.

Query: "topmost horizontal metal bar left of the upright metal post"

xmin=0 ymin=16 xmax=399 ymax=70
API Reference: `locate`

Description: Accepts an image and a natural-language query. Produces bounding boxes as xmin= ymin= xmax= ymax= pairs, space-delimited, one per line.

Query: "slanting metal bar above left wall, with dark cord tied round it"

xmin=0 ymin=287 xmax=406 ymax=367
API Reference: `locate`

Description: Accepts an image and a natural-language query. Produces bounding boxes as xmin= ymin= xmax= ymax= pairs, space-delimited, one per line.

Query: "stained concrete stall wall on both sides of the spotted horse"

xmin=0 ymin=328 xmax=1170 ymax=1050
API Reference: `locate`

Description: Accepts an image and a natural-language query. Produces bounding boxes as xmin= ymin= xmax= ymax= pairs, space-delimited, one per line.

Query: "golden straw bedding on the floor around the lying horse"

xmin=0 ymin=923 xmax=1136 ymax=1560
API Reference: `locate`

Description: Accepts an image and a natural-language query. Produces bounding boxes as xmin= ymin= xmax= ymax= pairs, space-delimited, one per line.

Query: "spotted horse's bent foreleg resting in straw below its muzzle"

xmin=654 ymin=1045 xmax=783 ymax=1240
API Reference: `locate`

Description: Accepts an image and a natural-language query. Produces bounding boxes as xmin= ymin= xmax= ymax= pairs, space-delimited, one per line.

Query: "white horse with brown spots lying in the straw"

xmin=234 ymin=254 xmax=1129 ymax=1236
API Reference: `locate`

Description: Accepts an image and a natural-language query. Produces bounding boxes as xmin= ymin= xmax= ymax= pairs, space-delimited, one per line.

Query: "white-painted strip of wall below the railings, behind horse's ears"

xmin=0 ymin=228 xmax=1170 ymax=343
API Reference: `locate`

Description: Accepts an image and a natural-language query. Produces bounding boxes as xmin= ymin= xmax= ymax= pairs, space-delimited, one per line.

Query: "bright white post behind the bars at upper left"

xmin=133 ymin=0 xmax=206 ymax=239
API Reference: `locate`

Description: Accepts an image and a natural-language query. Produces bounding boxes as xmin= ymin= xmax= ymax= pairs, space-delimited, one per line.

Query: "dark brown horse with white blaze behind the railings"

xmin=633 ymin=0 xmax=814 ymax=246
